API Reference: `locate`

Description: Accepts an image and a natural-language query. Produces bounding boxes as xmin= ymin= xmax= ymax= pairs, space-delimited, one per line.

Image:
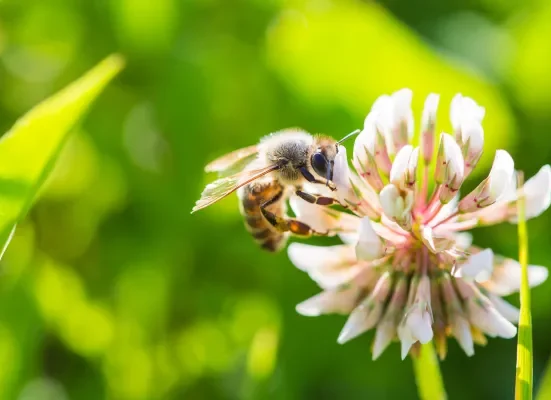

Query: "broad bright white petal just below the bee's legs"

xmin=287 ymin=243 xmax=365 ymax=289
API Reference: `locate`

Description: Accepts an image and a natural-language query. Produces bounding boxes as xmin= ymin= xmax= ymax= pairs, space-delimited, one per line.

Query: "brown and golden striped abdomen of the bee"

xmin=239 ymin=179 xmax=287 ymax=251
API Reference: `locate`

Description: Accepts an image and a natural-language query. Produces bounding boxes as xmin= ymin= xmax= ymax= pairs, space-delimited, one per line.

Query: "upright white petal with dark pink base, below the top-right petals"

xmin=434 ymin=133 xmax=465 ymax=203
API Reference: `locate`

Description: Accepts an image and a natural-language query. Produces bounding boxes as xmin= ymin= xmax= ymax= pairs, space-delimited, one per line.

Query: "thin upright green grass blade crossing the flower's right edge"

xmin=515 ymin=173 xmax=533 ymax=400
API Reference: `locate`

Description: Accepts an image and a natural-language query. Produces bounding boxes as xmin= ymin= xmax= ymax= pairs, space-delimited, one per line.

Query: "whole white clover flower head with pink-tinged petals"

xmin=289 ymin=89 xmax=551 ymax=359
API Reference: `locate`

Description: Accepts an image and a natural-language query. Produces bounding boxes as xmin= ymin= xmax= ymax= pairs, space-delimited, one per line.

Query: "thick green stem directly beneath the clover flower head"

xmin=412 ymin=342 xmax=447 ymax=400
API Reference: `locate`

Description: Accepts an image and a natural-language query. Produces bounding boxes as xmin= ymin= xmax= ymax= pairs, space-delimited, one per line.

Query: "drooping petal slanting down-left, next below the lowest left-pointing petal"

xmin=337 ymin=272 xmax=392 ymax=344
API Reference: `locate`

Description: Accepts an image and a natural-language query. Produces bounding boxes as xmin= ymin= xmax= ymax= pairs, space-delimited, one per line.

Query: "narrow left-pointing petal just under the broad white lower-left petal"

xmin=296 ymin=287 xmax=360 ymax=317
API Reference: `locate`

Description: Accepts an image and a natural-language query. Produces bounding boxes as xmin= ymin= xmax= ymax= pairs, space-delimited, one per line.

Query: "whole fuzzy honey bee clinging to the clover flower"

xmin=192 ymin=129 xmax=357 ymax=252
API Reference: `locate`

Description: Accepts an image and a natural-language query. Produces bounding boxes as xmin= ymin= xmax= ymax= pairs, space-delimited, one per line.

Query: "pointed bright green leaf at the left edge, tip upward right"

xmin=0 ymin=55 xmax=124 ymax=252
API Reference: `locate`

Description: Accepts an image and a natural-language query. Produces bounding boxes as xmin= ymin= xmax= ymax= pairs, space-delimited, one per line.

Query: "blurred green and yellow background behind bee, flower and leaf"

xmin=0 ymin=0 xmax=551 ymax=400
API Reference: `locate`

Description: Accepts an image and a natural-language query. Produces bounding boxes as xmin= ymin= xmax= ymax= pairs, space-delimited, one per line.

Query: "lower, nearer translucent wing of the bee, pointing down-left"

xmin=191 ymin=164 xmax=279 ymax=213
